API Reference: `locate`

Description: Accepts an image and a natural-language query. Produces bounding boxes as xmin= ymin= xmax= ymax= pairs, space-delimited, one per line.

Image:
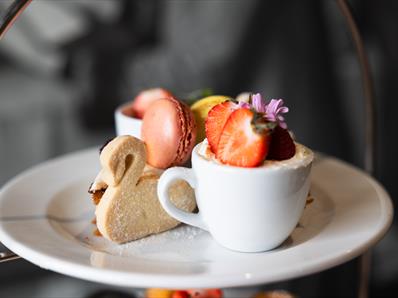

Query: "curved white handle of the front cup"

xmin=157 ymin=167 xmax=208 ymax=231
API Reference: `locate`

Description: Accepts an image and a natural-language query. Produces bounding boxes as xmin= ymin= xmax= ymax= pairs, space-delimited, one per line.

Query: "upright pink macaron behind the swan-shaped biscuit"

xmin=141 ymin=98 xmax=196 ymax=169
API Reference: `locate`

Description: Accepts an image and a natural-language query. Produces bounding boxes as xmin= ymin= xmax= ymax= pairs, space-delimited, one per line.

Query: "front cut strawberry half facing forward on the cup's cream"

xmin=216 ymin=108 xmax=269 ymax=168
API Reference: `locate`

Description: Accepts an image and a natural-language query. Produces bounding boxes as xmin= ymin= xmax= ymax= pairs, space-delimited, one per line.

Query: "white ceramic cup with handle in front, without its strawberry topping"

xmin=158 ymin=144 xmax=313 ymax=252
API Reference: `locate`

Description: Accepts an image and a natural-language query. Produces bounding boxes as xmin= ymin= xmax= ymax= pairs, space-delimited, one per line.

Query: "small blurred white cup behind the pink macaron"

xmin=115 ymin=103 xmax=142 ymax=139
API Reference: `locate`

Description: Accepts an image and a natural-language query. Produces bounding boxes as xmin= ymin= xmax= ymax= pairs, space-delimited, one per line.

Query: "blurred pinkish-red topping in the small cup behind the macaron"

xmin=131 ymin=88 xmax=174 ymax=119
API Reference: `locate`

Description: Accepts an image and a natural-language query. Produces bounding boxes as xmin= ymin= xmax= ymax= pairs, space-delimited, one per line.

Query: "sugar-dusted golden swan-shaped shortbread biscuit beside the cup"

xmin=91 ymin=136 xmax=196 ymax=243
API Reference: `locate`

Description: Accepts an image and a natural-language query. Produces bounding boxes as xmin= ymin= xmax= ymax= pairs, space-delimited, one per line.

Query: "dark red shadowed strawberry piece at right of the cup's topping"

xmin=267 ymin=126 xmax=296 ymax=160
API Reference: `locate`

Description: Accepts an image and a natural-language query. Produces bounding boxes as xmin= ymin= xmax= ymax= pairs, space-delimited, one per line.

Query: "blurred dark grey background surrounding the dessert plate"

xmin=0 ymin=0 xmax=398 ymax=297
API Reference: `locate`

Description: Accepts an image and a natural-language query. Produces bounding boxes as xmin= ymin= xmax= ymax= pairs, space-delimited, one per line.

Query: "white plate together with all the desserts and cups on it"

xmin=0 ymin=88 xmax=393 ymax=288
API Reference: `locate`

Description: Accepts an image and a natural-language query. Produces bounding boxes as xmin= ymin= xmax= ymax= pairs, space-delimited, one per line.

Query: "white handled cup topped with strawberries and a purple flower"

xmin=158 ymin=94 xmax=314 ymax=252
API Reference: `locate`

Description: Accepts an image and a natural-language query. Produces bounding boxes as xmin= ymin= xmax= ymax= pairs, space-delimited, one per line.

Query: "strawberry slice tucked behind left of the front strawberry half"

xmin=205 ymin=101 xmax=236 ymax=153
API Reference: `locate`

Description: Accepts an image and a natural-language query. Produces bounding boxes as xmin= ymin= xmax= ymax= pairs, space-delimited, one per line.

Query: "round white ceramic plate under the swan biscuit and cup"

xmin=0 ymin=149 xmax=393 ymax=288
